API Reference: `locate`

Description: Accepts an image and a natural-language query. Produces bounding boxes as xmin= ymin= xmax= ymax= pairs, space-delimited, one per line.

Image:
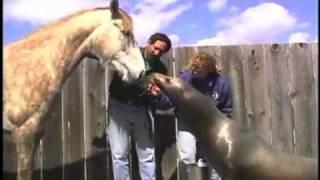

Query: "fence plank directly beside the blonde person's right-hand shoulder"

xmin=219 ymin=46 xmax=248 ymax=126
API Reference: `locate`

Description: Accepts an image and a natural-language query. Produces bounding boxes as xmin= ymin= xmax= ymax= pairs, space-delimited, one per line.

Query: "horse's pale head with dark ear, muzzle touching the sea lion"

xmin=102 ymin=0 xmax=145 ymax=82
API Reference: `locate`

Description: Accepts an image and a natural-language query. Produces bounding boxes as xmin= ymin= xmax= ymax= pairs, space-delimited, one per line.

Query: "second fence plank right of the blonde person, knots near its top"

xmin=244 ymin=45 xmax=272 ymax=144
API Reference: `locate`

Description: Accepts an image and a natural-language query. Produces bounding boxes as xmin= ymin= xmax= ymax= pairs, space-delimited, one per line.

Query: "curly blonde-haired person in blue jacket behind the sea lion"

xmin=177 ymin=52 xmax=233 ymax=180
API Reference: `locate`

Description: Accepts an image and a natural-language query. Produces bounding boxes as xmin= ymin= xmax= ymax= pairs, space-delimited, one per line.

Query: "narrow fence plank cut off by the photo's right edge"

xmin=310 ymin=43 xmax=319 ymax=158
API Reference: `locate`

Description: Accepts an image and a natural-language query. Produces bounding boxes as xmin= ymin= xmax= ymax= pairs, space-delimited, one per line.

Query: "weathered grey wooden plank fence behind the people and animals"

xmin=3 ymin=43 xmax=319 ymax=180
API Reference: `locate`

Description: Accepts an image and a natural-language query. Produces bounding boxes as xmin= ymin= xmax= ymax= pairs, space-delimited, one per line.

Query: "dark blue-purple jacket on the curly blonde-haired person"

xmin=180 ymin=70 xmax=233 ymax=116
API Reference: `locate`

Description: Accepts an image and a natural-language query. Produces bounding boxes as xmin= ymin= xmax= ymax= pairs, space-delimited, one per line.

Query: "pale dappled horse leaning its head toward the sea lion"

xmin=3 ymin=0 xmax=145 ymax=180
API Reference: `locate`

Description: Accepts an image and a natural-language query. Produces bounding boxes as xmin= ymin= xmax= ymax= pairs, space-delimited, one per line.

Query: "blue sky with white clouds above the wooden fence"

xmin=3 ymin=0 xmax=319 ymax=47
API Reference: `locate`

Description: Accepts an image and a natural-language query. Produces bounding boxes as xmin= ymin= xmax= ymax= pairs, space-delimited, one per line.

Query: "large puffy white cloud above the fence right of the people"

xmin=196 ymin=3 xmax=297 ymax=45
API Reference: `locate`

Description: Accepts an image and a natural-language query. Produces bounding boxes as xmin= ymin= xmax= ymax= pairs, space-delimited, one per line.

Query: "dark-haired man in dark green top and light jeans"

xmin=107 ymin=33 xmax=171 ymax=180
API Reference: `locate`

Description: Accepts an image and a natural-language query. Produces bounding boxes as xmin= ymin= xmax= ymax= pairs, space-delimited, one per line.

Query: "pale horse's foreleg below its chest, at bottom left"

xmin=13 ymin=115 xmax=41 ymax=180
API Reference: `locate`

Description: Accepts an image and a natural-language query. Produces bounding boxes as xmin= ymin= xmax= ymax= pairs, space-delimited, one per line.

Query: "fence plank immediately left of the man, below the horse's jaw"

xmin=83 ymin=59 xmax=112 ymax=180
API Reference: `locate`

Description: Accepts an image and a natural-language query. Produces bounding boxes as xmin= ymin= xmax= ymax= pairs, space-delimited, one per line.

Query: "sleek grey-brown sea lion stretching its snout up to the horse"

xmin=148 ymin=74 xmax=318 ymax=180
